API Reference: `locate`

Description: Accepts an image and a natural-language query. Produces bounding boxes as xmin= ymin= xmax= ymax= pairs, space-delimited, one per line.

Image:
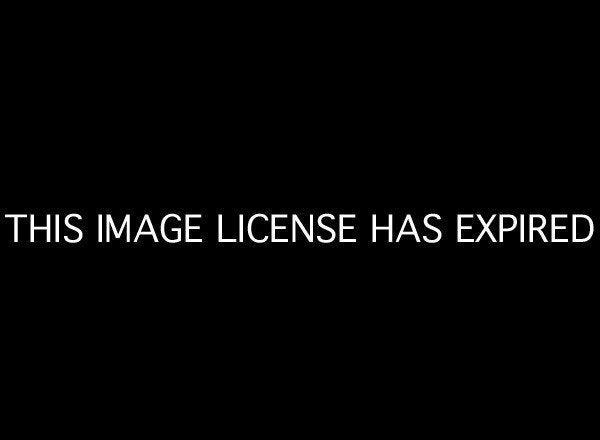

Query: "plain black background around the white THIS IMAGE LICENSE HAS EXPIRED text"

xmin=1 ymin=5 xmax=598 ymax=433
